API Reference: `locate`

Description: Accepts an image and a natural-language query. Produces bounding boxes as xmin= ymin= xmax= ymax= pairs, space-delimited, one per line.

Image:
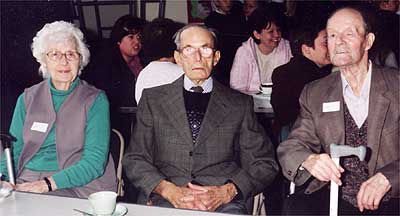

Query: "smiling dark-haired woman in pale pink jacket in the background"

xmin=230 ymin=8 xmax=292 ymax=92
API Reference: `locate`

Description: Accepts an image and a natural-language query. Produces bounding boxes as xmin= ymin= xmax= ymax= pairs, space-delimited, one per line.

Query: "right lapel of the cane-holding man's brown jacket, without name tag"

xmin=367 ymin=69 xmax=390 ymax=174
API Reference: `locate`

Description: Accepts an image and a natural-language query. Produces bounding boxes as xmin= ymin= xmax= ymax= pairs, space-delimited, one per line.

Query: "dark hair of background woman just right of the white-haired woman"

xmin=110 ymin=14 xmax=147 ymax=44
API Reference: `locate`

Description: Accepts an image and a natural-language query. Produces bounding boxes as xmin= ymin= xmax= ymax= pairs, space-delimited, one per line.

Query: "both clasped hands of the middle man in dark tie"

xmin=155 ymin=180 xmax=237 ymax=211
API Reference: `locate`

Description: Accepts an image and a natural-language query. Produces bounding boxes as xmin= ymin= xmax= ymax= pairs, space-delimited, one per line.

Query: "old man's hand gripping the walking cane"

xmin=302 ymin=153 xmax=344 ymax=185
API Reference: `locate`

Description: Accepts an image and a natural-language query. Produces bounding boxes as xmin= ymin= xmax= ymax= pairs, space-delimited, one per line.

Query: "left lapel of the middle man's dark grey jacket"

xmin=161 ymin=76 xmax=192 ymax=144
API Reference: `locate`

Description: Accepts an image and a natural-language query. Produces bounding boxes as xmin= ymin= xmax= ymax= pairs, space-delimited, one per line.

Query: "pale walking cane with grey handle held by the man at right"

xmin=329 ymin=144 xmax=367 ymax=216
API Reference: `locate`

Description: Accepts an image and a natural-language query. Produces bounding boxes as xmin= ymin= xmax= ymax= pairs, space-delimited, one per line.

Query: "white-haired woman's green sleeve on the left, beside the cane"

xmin=0 ymin=93 xmax=26 ymax=180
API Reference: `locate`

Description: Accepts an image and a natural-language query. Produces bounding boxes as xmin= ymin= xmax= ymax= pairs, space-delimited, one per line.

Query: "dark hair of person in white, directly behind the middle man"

xmin=143 ymin=18 xmax=184 ymax=65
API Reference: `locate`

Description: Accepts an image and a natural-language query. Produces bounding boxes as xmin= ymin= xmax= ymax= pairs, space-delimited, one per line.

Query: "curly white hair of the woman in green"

xmin=31 ymin=21 xmax=90 ymax=78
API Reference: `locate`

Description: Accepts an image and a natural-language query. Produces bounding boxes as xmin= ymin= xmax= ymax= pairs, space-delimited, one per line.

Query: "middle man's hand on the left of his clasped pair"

xmin=154 ymin=180 xmax=207 ymax=210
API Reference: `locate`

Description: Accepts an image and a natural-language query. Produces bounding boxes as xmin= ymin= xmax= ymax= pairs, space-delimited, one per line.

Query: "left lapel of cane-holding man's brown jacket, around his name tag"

xmin=321 ymin=72 xmax=345 ymax=152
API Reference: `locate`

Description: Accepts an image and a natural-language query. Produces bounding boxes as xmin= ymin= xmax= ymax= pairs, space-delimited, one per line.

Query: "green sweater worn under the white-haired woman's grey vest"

xmin=0 ymin=78 xmax=110 ymax=189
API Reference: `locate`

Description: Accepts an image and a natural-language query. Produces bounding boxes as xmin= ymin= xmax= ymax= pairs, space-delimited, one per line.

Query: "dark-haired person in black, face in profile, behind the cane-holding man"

xmin=271 ymin=22 xmax=331 ymax=136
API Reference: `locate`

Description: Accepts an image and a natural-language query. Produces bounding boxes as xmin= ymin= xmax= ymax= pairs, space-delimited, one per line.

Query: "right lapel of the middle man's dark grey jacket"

xmin=196 ymin=80 xmax=230 ymax=147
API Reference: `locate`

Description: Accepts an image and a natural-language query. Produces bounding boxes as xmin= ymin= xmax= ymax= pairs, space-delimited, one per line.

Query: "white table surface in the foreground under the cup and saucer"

xmin=0 ymin=192 xmax=231 ymax=216
